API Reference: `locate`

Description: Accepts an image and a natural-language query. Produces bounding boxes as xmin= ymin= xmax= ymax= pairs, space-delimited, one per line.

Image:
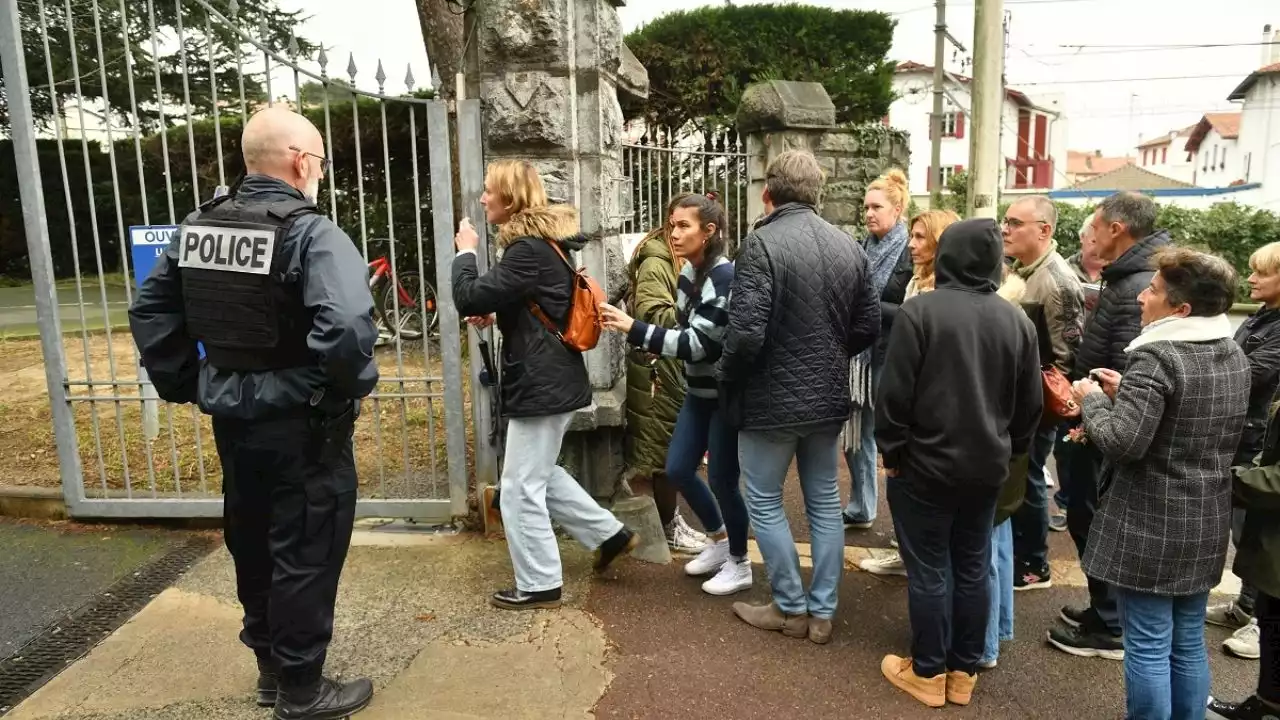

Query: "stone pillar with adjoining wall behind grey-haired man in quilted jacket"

xmin=737 ymin=81 xmax=910 ymax=237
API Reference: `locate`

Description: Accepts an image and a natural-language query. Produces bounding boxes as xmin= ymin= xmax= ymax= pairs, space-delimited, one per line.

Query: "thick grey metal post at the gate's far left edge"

xmin=0 ymin=0 xmax=84 ymax=515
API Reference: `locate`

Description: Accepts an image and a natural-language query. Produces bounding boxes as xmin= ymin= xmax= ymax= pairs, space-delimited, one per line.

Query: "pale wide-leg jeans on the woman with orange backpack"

xmin=500 ymin=413 xmax=622 ymax=592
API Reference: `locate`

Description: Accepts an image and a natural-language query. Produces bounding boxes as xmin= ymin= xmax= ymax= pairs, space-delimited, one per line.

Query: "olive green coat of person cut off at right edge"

xmin=1231 ymin=397 xmax=1280 ymax=597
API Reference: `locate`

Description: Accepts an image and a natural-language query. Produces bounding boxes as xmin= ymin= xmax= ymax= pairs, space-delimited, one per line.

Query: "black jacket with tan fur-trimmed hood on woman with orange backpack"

xmin=453 ymin=205 xmax=591 ymax=418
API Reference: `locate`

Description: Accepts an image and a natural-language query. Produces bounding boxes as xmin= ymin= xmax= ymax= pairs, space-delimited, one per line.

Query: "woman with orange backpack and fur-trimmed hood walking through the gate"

xmin=453 ymin=160 xmax=639 ymax=610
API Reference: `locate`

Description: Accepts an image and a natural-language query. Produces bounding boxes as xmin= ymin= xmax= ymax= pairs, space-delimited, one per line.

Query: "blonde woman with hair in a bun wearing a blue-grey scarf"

xmin=845 ymin=169 xmax=913 ymax=529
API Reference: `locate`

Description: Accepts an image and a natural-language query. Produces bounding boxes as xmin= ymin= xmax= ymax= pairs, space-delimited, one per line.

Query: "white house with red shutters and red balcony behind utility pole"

xmin=884 ymin=61 xmax=1066 ymax=204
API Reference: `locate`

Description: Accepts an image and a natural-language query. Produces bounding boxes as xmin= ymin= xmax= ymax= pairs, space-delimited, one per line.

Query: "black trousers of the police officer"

xmin=214 ymin=409 xmax=357 ymax=687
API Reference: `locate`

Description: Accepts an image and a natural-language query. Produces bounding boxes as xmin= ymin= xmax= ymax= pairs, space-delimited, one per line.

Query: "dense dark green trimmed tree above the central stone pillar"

xmin=623 ymin=5 xmax=896 ymax=129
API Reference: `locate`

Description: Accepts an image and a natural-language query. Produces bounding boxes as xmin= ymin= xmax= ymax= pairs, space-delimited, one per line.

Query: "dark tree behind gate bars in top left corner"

xmin=0 ymin=0 xmax=316 ymax=132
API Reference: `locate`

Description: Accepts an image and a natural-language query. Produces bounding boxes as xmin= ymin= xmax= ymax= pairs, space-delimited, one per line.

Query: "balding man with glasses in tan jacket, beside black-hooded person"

xmin=1002 ymin=195 xmax=1084 ymax=591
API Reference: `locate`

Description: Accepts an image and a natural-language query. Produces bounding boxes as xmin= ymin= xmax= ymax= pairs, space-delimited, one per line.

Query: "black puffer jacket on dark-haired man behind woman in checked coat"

xmin=1073 ymin=231 xmax=1171 ymax=379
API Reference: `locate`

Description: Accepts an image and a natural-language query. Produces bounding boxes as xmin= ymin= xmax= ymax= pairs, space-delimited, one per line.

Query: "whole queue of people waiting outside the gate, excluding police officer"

xmin=454 ymin=151 xmax=1280 ymax=720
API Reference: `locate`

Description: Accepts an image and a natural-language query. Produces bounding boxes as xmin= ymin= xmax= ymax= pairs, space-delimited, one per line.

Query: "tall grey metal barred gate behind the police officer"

xmin=0 ymin=0 xmax=486 ymax=521
